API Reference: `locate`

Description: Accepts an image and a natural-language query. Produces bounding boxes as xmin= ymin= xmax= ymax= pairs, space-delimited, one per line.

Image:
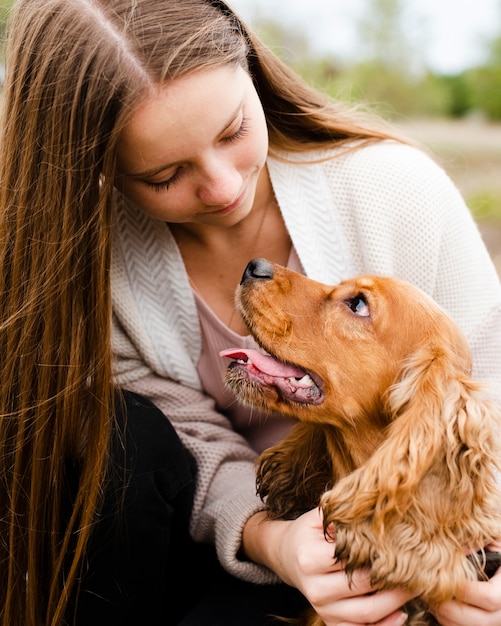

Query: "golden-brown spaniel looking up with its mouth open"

xmin=221 ymin=259 xmax=501 ymax=626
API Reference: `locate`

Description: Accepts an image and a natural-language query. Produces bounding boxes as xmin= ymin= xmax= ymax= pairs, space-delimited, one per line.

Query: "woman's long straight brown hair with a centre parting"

xmin=0 ymin=0 xmax=398 ymax=626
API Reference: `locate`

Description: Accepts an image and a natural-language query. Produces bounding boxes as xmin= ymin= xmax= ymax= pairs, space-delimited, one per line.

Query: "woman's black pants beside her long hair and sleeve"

xmin=68 ymin=392 xmax=306 ymax=626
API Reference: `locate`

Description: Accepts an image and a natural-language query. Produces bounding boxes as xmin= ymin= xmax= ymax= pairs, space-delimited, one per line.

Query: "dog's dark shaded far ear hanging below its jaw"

xmin=257 ymin=422 xmax=332 ymax=519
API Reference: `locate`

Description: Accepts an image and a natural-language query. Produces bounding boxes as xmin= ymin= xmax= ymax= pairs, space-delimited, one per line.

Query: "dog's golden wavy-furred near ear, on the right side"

xmin=322 ymin=347 xmax=499 ymax=532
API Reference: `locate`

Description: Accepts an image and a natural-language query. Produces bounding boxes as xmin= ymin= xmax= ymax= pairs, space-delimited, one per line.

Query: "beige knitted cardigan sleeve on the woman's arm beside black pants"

xmin=113 ymin=318 xmax=278 ymax=583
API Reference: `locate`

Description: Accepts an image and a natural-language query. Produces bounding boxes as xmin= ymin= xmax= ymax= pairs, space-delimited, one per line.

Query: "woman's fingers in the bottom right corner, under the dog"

xmin=433 ymin=538 xmax=501 ymax=626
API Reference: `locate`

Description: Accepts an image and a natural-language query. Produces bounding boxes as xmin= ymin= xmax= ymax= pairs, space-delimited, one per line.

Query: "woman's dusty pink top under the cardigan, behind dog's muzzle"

xmin=193 ymin=248 xmax=304 ymax=452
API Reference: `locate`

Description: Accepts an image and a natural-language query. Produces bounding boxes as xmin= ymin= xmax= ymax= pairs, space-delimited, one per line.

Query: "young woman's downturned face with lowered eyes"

xmin=116 ymin=65 xmax=268 ymax=226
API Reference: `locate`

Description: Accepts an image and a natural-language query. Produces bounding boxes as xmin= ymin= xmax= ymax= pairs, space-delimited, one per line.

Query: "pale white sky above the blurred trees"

xmin=228 ymin=0 xmax=501 ymax=74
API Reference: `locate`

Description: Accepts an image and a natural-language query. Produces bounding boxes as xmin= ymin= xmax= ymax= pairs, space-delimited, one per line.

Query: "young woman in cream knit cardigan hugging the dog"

xmin=0 ymin=0 xmax=501 ymax=626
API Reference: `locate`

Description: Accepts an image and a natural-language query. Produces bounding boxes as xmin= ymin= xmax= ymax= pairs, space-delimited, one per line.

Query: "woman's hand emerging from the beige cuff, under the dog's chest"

xmin=243 ymin=509 xmax=410 ymax=626
